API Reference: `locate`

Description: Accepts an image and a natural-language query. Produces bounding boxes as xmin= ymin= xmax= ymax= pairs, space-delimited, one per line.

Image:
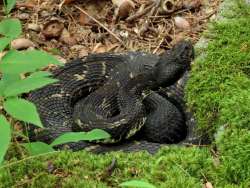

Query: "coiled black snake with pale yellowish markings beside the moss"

xmin=28 ymin=41 xmax=194 ymax=153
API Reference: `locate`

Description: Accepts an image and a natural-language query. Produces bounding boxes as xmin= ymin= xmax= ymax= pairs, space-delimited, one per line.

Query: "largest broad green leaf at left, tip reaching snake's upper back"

xmin=0 ymin=50 xmax=62 ymax=74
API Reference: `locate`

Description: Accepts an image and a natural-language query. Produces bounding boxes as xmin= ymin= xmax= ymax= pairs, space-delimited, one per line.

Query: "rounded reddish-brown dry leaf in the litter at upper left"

xmin=42 ymin=20 xmax=64 ymax=39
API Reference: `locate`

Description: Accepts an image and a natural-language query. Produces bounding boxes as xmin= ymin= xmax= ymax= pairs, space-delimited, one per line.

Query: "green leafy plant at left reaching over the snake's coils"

xmin=0 ymin=12 xmax=110 ymax=163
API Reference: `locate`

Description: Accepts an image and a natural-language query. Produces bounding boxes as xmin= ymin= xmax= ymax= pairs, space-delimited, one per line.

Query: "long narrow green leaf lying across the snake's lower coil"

xmin=50 ymin=129 xmax=110 ymax=146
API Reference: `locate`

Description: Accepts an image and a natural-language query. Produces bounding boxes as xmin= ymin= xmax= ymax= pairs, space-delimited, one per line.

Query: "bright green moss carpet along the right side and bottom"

xmin=0 ymin=0 xmax=250 ymax=188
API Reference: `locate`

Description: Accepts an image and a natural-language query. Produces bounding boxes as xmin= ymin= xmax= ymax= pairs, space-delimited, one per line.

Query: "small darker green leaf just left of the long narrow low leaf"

xmin=22 ymin=142 xmax=55 ymax=155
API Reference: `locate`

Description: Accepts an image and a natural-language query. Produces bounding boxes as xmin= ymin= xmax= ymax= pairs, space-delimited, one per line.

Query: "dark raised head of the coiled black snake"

xmin=154 ymin=40 xmax=194 ymax=87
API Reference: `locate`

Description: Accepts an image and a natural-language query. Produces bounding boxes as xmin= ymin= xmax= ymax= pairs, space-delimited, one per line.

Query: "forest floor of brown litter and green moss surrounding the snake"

xmin=0 ymin=0 xmax=250 ymax=188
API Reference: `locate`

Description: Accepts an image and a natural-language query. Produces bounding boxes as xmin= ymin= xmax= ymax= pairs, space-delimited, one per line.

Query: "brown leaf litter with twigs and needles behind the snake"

xmin=0 ymin=0 xmax=220 ymax=62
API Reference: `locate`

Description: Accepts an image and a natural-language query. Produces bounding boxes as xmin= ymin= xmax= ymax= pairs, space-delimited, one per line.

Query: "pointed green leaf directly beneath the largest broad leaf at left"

xmin=3 ymin=72 xmax=57 ymax=97
